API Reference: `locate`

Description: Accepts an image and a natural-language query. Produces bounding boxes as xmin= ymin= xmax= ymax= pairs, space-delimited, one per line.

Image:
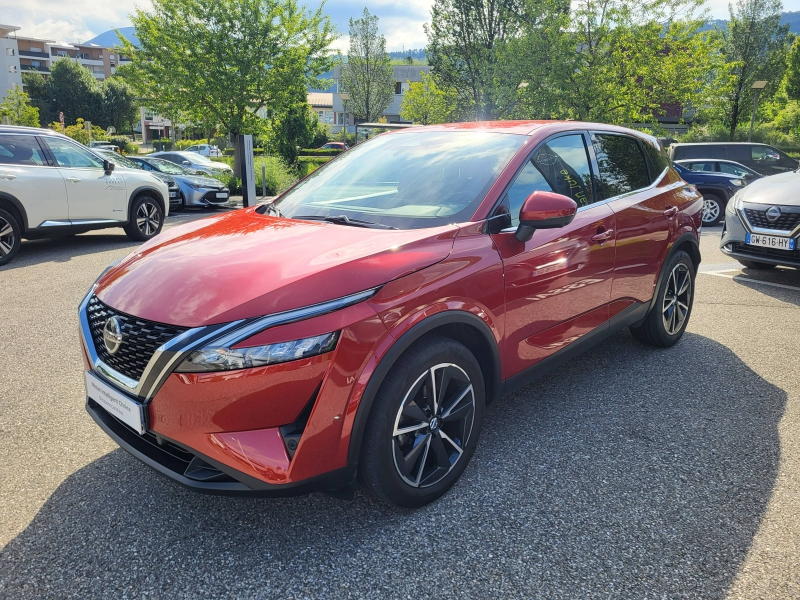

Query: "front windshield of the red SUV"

xmin=274 ymin=130 xmax=528 ymax=229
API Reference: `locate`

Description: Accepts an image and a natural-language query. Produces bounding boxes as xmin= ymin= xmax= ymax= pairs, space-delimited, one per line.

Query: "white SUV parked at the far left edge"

xmin=0 ymin=125 xmax=169 ymax=265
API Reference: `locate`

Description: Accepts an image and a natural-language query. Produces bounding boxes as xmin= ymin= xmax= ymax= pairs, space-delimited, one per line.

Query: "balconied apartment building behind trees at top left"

xmin=0 ymin=25 xmax=127 ymax=96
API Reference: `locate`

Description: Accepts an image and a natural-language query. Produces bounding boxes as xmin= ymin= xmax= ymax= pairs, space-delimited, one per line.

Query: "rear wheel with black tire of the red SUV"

xmin=630 ymin=250 xmax=696 ymax=348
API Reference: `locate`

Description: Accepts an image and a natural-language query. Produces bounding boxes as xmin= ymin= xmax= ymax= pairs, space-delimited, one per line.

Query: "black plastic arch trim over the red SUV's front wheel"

xmin=347 ymin=310 xmax=502 ymax=465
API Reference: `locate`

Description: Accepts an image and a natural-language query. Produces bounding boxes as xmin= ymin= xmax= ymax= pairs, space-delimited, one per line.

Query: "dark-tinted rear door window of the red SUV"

xmin=592 ymin=133 xmax=650 ymax=200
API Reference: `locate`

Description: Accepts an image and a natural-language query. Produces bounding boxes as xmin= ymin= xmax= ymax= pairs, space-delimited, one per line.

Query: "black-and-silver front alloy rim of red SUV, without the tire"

xmin=392 ymin=363 xmax=475 ymax=488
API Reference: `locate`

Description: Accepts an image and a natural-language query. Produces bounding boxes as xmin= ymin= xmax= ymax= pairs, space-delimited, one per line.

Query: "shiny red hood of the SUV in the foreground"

xmin=95 ymin=208 xmax=458 ymax=327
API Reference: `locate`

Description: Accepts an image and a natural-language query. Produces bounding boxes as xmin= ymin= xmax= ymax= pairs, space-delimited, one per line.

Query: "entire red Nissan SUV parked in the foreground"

xmin=80 ymin=122 xmax=703 ymax=507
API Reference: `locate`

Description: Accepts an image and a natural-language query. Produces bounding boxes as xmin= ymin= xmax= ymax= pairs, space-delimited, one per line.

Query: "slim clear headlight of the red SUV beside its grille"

xmin=175 ymin=331 xmax=339 ymax=373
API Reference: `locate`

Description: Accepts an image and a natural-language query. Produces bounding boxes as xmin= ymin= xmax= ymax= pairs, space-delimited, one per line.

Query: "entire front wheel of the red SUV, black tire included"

xmin=359 ymin=337 xmax=485 ymax=508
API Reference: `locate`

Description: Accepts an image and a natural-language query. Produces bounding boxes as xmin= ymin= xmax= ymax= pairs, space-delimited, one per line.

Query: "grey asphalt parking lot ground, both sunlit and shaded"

xmin=0 ymin=213 xmax=800 ymax=599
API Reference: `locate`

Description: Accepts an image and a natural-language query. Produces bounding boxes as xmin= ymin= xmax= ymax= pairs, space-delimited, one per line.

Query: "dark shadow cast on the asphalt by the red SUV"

xmin=0 ymin=332 xmax=786 ymax=598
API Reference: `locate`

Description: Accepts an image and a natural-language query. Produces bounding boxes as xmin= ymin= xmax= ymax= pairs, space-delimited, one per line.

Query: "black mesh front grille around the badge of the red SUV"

xmin=86 ymin=296 xmax=186 ymax=381
